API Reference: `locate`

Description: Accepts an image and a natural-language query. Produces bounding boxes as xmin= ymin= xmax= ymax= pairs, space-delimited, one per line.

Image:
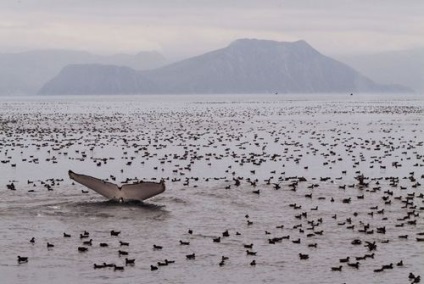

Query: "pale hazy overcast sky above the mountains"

xmin=0 ymin=0 xmax=424 ymax=58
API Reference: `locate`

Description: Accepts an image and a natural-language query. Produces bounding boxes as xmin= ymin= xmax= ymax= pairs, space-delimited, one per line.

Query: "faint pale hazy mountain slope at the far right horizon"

xmin=338 ymin=48 xmax=424 ymax=93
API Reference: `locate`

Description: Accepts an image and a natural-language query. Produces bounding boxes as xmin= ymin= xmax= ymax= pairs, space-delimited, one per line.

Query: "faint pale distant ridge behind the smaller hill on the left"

xmin=0 ymin=50 xmax=165 ymax=95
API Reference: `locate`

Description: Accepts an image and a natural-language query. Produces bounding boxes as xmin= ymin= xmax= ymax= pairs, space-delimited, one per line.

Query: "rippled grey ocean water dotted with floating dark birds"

xmin=0 ymin=94 xmax=424 ymax=283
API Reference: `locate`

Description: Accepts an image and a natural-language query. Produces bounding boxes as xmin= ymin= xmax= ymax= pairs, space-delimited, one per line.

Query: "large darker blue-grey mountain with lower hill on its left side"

xmin=39 ymin=39 xmax=408 ymax=95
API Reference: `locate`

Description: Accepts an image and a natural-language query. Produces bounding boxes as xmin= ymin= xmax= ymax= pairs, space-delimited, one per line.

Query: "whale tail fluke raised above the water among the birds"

xmin=68 ymin=170 xmax=165 ymax=202
